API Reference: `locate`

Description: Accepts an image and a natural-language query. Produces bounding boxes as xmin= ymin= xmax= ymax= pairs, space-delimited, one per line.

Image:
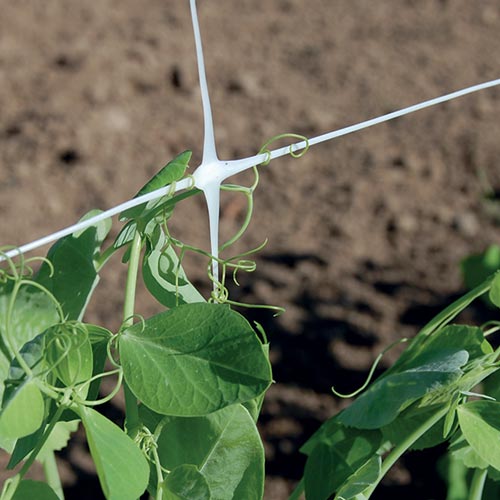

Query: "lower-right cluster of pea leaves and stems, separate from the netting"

xmin=294 ymin=274 xmax=500 ymax=500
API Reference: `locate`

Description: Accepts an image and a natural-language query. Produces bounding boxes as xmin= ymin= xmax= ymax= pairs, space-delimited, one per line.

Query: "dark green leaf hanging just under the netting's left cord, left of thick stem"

xmin=36 ymin=212 xmax=110 ymax=320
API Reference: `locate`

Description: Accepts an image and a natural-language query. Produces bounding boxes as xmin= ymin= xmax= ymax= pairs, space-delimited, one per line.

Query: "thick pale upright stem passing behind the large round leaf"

xmin=123 ymin=231 xmax=142 ymax=436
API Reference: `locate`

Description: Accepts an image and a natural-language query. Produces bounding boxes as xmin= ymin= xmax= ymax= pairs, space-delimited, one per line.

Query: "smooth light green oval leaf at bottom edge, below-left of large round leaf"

xmin=78 ymin=406 xmax=149 ymax=500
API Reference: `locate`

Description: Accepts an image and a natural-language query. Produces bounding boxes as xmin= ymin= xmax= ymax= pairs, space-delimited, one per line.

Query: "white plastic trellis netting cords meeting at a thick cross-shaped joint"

xmin=0 ymin=0 xmax=500 ymax=266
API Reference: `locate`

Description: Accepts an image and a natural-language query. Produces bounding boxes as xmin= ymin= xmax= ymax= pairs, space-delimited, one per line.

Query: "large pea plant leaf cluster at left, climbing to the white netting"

xmin=0 ymin=152 xmax=272 ymax=500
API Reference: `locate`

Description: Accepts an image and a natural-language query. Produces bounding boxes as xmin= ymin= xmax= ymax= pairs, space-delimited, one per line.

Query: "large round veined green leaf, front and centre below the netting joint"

xmin=119 ymin=303 xmax=271 ymax=416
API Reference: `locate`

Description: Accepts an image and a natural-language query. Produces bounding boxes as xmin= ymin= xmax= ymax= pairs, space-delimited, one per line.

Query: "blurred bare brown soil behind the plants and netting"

xmin=0 ymin=0 xmax=500 ymax=500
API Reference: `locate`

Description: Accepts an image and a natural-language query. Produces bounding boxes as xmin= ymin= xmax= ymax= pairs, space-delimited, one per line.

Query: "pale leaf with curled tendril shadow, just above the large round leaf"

xmin=142 ymin=243 xmax=205 ymax=308
